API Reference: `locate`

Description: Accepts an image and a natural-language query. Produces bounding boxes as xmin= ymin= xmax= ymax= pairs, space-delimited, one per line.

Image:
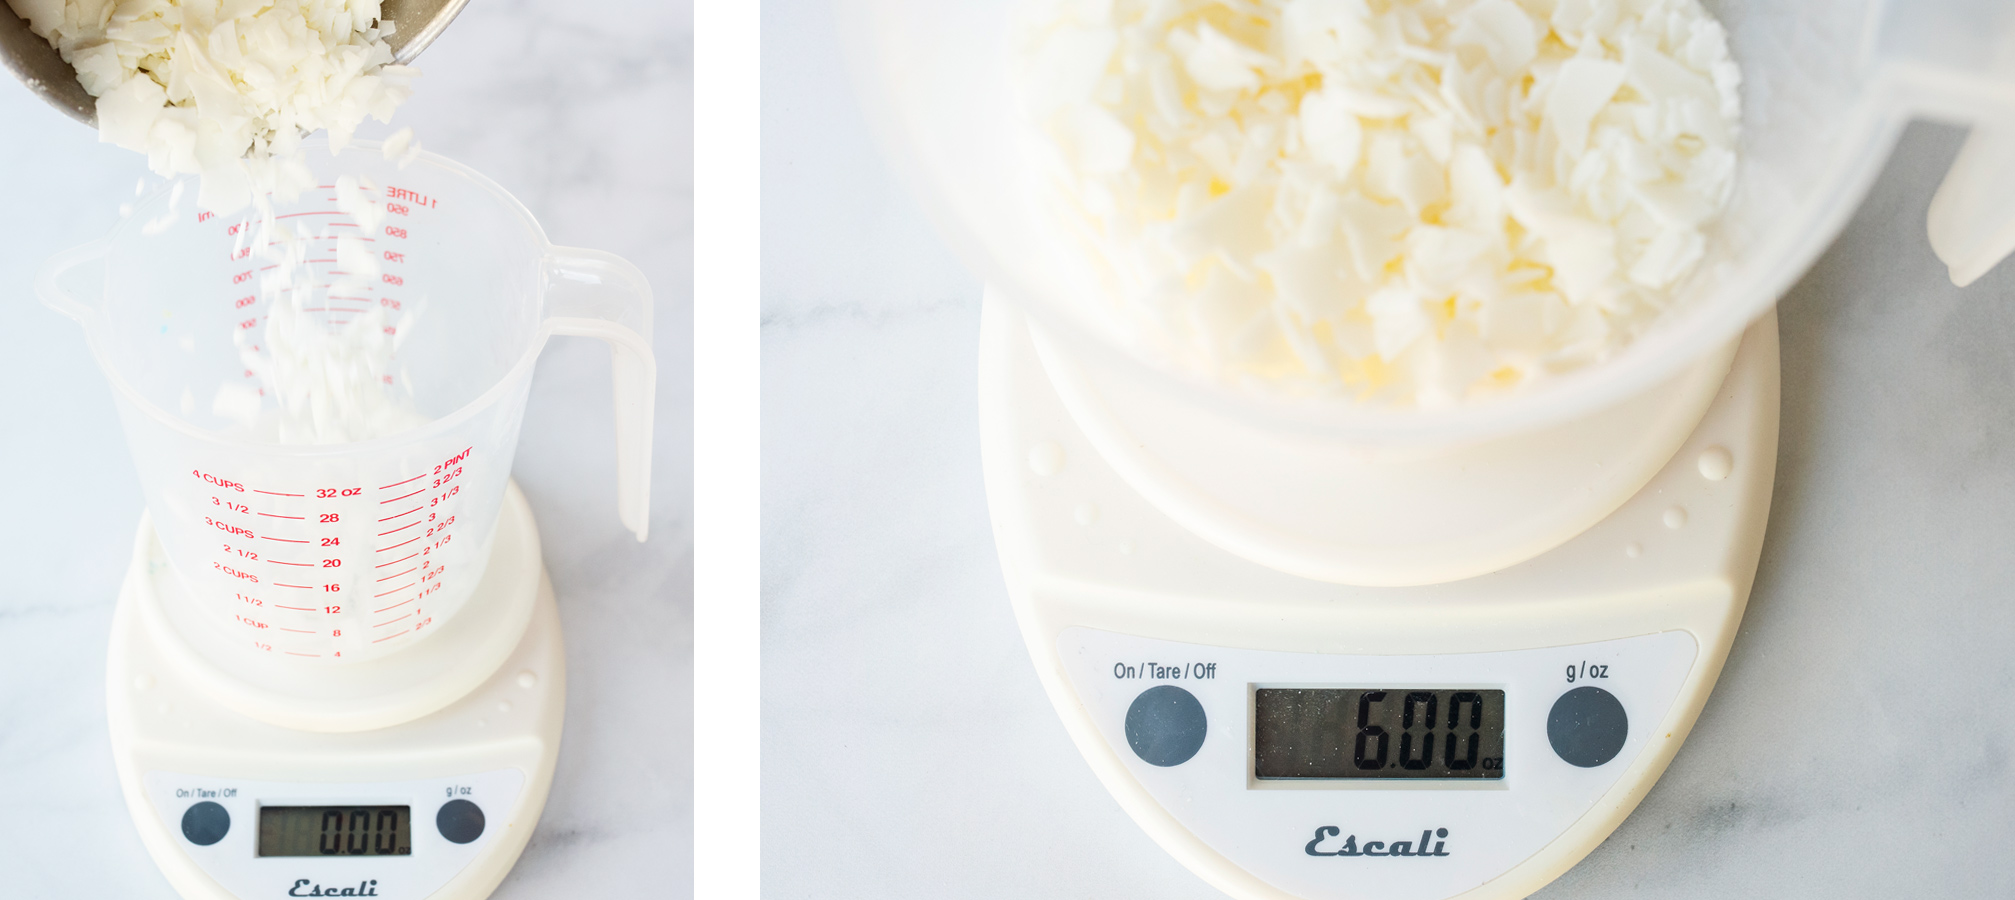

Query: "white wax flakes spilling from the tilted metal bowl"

xmin=8 ymin=0 xmax=419 ymax=213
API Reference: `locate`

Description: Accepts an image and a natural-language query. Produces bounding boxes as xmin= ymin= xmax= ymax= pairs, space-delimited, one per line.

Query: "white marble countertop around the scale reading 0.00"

xmin=0 ymin=0 xmax=693 ymax=900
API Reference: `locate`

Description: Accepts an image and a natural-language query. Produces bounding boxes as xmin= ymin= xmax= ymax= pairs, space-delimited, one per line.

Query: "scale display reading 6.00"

xmin=1253 ymin=687 xmax=1505 ymax=779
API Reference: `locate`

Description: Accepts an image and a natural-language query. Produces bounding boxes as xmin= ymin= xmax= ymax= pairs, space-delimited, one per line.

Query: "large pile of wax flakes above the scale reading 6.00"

xmin=1020 ymin=0 xmax=1741 ymax=407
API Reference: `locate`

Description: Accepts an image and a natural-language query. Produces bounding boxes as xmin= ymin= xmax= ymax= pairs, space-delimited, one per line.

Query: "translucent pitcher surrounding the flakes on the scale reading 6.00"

xmin=842 ymin=0 xmax=2015 ymax=445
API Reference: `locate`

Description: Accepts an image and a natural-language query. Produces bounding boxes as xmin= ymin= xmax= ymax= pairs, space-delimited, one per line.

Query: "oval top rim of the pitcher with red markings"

xmin=85 ymin=137 xmax=552 ymax=459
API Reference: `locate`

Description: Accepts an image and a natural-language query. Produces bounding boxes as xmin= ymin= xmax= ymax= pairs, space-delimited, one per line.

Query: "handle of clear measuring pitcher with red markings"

xmin=544 ymin=248 xmax=657 ymax=542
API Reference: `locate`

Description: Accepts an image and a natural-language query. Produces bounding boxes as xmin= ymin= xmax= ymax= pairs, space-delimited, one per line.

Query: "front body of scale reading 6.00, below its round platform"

xmin=979 ymin=298 xmax=1777 ymax=900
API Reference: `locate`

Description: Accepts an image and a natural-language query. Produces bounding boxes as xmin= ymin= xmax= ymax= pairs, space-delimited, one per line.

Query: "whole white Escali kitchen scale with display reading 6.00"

xmin=979 ymin=296 xmax=1777 ymax=900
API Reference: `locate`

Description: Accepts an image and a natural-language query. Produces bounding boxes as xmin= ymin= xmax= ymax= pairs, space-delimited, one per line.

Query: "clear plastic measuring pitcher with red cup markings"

xmin=36 ymin=141 xmax=655 ymax=662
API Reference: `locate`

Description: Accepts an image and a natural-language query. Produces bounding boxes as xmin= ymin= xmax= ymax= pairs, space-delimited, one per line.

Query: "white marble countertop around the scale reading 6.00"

xmin=762 ymin=0 xmax=2015 ymax=900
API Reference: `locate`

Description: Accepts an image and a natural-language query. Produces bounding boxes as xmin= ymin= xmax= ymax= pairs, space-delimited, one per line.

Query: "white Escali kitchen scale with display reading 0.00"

xmin=107 ymin=485 xmax=566 ymax=900
